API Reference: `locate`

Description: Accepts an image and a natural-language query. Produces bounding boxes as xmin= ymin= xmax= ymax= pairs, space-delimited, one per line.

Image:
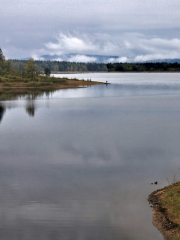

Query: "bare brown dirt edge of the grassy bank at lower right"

xmin=148 ymin=183 xmax=180 ymax=240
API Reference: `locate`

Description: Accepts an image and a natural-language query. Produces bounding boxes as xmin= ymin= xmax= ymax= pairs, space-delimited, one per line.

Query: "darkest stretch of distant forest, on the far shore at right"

xmin=106 ymin=62 xmax=180 ymax=72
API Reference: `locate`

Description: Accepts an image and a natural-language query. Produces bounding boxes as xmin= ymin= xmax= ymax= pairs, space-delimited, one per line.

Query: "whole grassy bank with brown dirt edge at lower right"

xmin=148 ymin=182 xmax=180 ymax=240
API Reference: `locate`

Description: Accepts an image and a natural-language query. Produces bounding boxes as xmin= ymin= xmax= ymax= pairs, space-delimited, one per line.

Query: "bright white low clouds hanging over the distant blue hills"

xmin=5 ymin=33 xmax=180 ymax=63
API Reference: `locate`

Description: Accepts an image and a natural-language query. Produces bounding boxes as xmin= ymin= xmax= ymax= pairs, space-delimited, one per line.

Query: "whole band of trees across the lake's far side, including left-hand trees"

xmin=0 ymin=45 xmax=180 ymax=74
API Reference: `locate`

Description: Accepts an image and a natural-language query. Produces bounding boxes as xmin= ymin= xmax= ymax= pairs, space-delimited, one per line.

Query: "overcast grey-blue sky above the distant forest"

xmin=0 ymin=0 xmax=180 ymax=62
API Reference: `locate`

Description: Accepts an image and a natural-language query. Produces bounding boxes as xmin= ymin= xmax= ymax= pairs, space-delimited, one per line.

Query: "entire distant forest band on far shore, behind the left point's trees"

xmin=9 ymin=60 xmax=180 ymax=72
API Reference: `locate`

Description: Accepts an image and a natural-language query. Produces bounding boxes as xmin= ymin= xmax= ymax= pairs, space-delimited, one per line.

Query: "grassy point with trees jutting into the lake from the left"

xmin=0 ymin=48 xmax=105 ymax=91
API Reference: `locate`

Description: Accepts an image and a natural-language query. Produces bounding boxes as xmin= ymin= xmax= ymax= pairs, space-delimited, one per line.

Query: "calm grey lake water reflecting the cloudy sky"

xmin=0 ymin=73 xmax=180 ymax=240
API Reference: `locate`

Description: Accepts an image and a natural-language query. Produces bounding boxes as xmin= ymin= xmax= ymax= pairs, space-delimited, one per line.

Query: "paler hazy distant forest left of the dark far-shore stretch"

xmin=10 ymin=60 xmax=107 ymax=72
